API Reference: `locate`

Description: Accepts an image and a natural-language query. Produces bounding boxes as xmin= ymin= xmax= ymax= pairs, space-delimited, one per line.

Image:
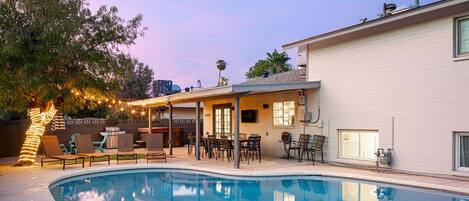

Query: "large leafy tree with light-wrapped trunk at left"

xmin=0 ymin=0 xmax=145 ymax=165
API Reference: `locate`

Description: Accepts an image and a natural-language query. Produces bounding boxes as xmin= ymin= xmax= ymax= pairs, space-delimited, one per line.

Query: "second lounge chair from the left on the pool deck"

xmin=75 ymin=135 xmax=111 ymax=167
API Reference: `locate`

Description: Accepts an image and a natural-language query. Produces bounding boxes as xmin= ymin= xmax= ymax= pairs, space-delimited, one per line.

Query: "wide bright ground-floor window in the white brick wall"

xmin=339 ymin=130 xmax=379 ymax=160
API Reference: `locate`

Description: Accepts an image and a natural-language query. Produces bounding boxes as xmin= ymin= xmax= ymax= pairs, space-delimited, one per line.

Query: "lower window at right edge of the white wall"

xmin=455 ymin=133 xmax=469 ymax=171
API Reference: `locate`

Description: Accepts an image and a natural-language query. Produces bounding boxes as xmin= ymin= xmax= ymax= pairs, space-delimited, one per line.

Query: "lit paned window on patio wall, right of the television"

xmin=273 ymin=101 xmax=295 ymax=126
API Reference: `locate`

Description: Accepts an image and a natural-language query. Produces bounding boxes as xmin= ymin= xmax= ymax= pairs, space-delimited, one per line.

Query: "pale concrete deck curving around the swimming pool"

xmin=0 ymin=148 xmax=469 ymax=201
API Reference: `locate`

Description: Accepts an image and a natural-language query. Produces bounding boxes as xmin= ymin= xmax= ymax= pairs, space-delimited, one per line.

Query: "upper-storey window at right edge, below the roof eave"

xmin=455 ymin=17 xmax=469 ymax=56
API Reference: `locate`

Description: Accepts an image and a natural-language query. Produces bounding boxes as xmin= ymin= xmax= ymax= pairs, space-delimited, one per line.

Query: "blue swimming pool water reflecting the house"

xmin=50 ymin=169 xmax=469 ymax=201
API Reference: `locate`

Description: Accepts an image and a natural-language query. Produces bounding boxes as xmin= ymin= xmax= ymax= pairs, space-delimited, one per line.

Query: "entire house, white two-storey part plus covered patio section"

xmin=131 ymin=0 xmax=469 ymax=176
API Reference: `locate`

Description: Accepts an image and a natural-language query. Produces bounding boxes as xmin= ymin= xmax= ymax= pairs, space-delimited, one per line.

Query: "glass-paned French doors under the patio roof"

xmin=213 ymin=104 xmax=231 ymax=137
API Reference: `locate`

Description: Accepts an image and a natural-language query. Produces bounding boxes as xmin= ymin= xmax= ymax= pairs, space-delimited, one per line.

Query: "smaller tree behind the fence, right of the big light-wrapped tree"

xmin=120 ymin=61 xmax=153 ymax=99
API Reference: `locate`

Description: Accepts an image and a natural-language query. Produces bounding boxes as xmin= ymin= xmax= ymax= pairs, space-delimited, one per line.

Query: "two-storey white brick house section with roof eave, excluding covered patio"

xmin=283 ymin=0 xmax=469 ymax=175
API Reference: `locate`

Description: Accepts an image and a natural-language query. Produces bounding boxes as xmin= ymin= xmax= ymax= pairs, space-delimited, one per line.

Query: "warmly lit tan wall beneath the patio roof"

xmin=203 ymin=90 xmax=322 ymax=157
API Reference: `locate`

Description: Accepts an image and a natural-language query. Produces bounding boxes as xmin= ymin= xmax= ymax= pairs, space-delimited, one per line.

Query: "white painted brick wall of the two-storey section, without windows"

xmin=308 ymin=14 xmax=469 ymax=174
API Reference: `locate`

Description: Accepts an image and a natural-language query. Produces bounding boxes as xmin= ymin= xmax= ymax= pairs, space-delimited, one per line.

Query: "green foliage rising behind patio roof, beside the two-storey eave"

xmin=246 ymin=49 xmax=292 ymax=79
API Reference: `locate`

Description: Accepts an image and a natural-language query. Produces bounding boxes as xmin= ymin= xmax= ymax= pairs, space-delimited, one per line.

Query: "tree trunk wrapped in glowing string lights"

xmin=15 ymin=105 xmax=57 ymax=166
